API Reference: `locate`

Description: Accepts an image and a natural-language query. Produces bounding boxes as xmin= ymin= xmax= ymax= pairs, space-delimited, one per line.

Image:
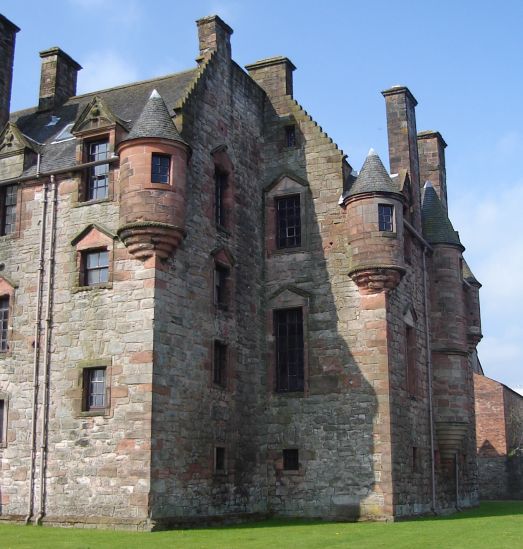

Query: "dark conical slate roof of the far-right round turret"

xmin=421 ymin=181 xmax=461 ymax=246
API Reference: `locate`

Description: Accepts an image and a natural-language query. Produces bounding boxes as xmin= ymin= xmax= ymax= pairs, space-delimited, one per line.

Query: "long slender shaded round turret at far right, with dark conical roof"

xmin=422 ymin=181 xmax=473 ymax=460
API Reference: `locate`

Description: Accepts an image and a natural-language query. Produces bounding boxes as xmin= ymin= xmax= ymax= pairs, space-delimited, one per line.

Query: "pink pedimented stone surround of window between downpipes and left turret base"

xmin=71 ymin=224 xmax=116 ymax=292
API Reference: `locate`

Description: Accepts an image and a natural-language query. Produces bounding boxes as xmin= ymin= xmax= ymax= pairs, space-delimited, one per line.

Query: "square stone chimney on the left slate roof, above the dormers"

xmin=38 ymin=48 xmax=82 ymax=111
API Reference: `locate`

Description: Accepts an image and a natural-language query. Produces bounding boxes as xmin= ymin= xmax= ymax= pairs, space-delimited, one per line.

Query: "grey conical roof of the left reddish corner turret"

xmin=123 ymin=90 xmax=185 ymax=143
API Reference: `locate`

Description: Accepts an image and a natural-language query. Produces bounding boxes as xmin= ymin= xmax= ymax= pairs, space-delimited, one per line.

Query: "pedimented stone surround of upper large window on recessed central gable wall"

xmin=264 ymin=174 xmax=309 ymax=257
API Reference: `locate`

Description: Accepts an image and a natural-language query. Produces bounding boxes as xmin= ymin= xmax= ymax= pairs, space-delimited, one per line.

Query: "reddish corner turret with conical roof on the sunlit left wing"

xmin=118 ymin=90 xmax=189 ymax=259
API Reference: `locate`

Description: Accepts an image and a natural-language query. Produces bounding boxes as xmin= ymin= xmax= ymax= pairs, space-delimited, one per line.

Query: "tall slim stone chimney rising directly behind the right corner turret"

xmin=381 ymin=86 xmax=421 ymax=230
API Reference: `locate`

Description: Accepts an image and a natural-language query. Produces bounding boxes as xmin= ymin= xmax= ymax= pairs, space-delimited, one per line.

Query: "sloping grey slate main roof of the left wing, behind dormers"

xmin=10 ymin=68 xmax=199 ymax=176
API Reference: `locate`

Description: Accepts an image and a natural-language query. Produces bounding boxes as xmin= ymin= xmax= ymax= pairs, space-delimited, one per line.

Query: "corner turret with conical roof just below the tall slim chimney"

xmin=344 ymin=149 xmax=405 ymax=293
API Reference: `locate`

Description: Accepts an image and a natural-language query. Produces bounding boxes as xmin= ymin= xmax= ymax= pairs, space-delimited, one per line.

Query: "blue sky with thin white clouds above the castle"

xmin=0 ymin=0 xmax=523 ymax=394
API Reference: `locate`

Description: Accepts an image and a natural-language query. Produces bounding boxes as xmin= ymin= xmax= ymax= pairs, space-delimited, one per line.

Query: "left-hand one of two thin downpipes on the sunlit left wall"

xmin=24 ymin=153 xmax=48 ymax=525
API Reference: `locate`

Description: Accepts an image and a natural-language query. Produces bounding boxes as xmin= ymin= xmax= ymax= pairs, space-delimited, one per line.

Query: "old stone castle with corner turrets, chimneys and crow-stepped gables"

xmin=0 ymin=11 xmax=496 ymax=529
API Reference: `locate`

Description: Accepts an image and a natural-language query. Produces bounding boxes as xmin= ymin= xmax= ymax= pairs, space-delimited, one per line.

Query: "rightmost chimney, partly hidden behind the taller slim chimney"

xmin=418 ymin=131 xmax=448 ymax=212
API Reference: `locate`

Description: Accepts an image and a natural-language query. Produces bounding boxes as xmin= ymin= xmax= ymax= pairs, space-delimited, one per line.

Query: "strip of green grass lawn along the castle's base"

xmin=0 ymin=501 xmax=523 ymax=549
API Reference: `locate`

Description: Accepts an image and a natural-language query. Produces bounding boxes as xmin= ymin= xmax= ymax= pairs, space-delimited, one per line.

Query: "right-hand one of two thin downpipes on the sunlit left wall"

xmin=36 ymin=175 xmax=57 ymax=525
